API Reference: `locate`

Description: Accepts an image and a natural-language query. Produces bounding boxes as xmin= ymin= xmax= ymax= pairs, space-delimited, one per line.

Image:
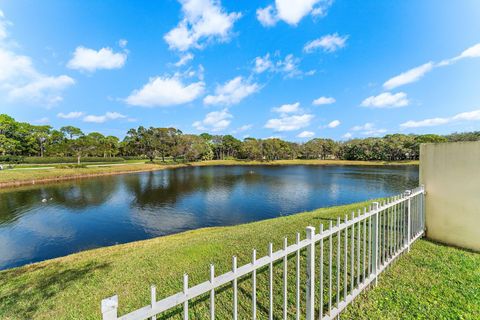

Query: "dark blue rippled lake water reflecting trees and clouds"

xmin=0 ymin=166 xmax=418 ymax=269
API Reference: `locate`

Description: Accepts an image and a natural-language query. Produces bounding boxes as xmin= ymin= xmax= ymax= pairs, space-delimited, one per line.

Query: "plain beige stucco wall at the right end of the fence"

xmin=420 ymin=141 xmax=480 ymax=251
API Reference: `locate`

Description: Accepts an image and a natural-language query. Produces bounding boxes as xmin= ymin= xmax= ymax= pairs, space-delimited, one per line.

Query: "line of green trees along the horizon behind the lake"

xmin=0 ymin=114 xmax=480 ymax=163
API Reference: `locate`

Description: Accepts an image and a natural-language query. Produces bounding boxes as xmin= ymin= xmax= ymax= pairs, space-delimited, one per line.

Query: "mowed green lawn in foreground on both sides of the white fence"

xmin=0 ymin=203 xmax=480 ymax=319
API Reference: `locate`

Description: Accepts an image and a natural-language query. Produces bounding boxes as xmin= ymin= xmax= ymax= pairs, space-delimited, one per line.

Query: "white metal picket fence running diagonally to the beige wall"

xmin=101 ymin=187 xmax=425 ymax=320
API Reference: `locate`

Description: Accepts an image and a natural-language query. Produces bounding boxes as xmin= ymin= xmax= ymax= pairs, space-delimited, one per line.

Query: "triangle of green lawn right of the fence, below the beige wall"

xmin=342 ymin=240 xmax=480 ymax=320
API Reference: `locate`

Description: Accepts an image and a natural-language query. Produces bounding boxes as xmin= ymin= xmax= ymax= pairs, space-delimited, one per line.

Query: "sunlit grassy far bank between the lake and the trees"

xmin=0 ymin=160 xmax=418 ymax=189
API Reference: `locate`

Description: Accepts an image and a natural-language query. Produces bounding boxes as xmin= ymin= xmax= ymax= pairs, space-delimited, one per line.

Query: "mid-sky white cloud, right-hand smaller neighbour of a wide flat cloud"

xmin=203 ymin=76 xmax=260 ymax=105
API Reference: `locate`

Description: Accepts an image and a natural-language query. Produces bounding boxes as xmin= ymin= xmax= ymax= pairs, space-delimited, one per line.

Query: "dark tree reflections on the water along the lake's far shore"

xmin=0 ymin=167 xmax=418 ymax=224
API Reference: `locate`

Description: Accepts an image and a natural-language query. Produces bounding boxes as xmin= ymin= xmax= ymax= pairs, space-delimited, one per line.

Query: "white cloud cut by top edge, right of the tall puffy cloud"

xmin=257 ymin=0 xmax=332 ymax=27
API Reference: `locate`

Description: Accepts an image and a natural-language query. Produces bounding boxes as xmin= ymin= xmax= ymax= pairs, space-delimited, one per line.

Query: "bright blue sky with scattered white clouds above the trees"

xmin=0 ymin=0 xmax=480 ymax=141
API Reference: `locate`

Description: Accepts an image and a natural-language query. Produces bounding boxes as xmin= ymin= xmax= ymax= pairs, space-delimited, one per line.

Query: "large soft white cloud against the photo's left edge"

xmin=0 ymin=11 xmax=75 ymax=105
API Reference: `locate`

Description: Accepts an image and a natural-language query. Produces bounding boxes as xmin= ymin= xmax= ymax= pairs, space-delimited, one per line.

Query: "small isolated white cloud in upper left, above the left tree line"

xmin=67 ymin=47 xmax=127 ymax=72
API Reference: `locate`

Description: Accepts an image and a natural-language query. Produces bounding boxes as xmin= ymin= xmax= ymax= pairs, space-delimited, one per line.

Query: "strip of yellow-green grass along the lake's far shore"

xmin=0 ymin=160 xmax=418 ymax=188
